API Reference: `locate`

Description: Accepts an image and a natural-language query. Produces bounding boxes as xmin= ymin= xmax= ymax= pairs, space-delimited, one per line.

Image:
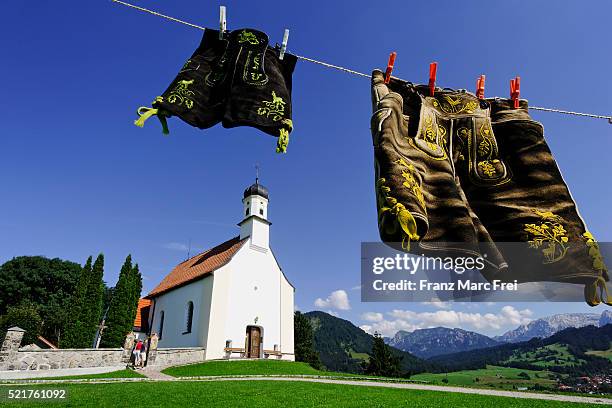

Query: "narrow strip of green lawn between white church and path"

xmin=162 ymin=360 xmax=354 ymax=377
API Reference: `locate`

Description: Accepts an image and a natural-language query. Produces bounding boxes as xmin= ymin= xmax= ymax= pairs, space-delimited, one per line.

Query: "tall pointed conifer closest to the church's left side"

xmin=100 ymin=255 xmax=142 ymax=347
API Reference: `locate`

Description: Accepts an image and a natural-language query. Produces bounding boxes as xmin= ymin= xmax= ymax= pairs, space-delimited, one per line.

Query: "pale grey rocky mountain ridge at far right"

xmin=493 ymin=312 xmax=606 ymax=343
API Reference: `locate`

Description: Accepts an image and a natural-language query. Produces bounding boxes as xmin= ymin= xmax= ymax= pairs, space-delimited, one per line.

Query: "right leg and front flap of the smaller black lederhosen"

xmin=223 ymin=29 xmax=297 ymax=152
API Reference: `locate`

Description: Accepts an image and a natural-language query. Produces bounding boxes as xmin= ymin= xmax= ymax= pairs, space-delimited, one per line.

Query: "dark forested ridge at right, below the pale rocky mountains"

xmin=429 ymin=325 xmax=612 ymax=376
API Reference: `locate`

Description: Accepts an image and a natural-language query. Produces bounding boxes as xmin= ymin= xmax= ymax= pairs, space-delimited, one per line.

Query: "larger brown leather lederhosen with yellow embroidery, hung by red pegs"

xmin=372 ymin=71 xmax=609 ymax=305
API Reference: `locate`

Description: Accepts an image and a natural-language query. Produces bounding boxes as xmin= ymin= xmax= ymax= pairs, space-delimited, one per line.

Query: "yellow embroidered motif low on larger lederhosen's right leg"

xmin=524 ymin=209 xmax=569 ymax=264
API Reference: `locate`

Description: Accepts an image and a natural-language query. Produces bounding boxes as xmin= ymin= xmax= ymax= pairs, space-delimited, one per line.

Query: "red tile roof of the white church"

xmin=145 ymin=237 xmax=246 ymax=299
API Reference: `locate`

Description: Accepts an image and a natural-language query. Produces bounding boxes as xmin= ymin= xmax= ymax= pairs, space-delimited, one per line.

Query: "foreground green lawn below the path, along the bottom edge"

xmin=0 ymin=381 xmax=589 ymax=408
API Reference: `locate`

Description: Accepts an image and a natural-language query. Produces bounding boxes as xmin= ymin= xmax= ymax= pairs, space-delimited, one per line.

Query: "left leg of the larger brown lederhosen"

xmin=371 ymin=71 xmax=506 ymax=273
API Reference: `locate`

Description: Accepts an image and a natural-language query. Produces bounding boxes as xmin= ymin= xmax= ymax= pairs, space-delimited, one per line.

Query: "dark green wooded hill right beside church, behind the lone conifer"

xmin=304 ymin=311 xmax=432 ymax=373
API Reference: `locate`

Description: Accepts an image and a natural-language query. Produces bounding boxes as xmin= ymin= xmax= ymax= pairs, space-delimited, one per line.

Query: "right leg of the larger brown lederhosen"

xmin=474 ymin=99 xmax=608 ymax=304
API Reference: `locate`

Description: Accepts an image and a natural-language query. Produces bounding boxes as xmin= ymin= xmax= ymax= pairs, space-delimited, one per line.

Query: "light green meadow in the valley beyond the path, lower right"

xmin=410 ymin=366 xmax=555 ymax=389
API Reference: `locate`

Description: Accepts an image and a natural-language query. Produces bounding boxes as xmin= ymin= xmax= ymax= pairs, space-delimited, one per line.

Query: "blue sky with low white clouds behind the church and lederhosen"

xmin=0 ymin=0 xmax=612 ymax=334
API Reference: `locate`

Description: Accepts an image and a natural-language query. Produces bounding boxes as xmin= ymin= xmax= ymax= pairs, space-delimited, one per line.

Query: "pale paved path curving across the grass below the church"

xmin=0 ymin=368 xmax=612 ymax=405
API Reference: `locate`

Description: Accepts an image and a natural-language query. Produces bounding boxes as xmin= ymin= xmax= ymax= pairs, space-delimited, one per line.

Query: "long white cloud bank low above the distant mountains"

xmin=361 ymin=306 xmax=533 ymax=336
